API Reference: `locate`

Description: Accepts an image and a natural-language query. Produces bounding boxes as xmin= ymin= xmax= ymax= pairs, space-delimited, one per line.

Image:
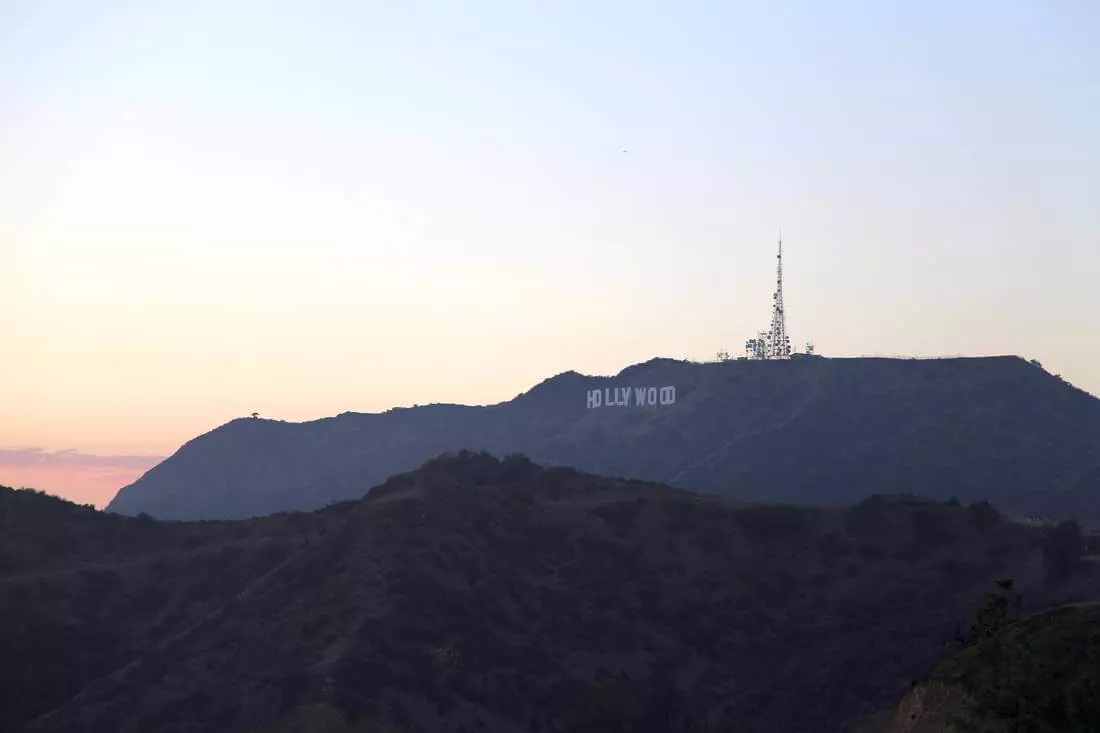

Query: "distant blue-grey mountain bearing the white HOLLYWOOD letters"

xmin=109 ymin=357 xmax=1100 ymax=522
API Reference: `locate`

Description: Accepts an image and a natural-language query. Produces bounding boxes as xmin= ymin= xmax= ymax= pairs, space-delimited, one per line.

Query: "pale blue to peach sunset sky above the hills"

xmin=0 ymin=0 xmax=1100 ymax=505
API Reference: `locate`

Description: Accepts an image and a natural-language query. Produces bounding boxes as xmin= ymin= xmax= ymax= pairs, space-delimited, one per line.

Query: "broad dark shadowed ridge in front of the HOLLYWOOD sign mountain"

xmin=8 ymin=451 xmax=1100 ymax=733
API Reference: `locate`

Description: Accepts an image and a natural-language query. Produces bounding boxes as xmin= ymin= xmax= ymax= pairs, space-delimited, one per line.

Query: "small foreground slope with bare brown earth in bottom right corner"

xmin=882 ymin=603 xmax=1100 ymax=733
